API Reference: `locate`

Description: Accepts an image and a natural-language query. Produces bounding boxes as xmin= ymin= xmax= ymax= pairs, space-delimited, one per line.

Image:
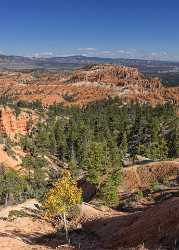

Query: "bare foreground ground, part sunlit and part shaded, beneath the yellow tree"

xmin=0 ymin=197 xmax=179 ymax=250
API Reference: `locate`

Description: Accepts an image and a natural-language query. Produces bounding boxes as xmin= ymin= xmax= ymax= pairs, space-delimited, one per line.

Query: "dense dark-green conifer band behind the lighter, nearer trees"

xmin=26 ymin=98 xmax=178 ymax=162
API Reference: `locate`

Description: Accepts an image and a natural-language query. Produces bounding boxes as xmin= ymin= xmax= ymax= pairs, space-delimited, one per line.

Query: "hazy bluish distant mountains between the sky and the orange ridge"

xmin=0 ymin=55 xmax=179 ymax=85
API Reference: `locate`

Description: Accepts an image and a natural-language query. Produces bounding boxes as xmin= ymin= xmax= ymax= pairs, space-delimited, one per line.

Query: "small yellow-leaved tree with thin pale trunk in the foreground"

xmin=43 ymin=173 xmax=82 ymax=241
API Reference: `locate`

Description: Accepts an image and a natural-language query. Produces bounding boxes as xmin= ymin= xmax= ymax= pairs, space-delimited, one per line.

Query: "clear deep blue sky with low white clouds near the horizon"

xmin=0 ymin=0 xmax=179 ymax=61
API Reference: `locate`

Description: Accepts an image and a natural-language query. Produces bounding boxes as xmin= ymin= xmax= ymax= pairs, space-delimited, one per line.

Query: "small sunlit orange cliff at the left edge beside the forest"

xmin=0 ymin=107 xmax=35 ymax=138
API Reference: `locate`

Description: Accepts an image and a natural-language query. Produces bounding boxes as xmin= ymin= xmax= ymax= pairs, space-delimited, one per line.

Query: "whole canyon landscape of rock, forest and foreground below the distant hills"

xmin=0 ymin=63 xmax=179 ymax=250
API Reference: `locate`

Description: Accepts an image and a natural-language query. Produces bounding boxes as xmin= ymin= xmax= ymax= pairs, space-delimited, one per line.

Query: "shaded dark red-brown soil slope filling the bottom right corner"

xmin=84 ymin=198 xmax=179 ymax=249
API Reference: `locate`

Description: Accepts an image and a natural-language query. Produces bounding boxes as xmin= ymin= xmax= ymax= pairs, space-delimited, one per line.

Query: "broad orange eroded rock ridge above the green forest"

xmin=0 ymin=64 xmax=179 ymax=106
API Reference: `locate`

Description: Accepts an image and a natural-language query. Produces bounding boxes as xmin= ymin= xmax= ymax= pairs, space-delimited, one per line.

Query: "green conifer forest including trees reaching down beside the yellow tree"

xmin=5 ymin=98 xmax=175 ymax=206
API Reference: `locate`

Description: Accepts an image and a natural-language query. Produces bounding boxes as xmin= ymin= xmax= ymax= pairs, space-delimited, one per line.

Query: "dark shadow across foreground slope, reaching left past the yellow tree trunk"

xmin=9 ymin=198 xmax=179 ymax=250
